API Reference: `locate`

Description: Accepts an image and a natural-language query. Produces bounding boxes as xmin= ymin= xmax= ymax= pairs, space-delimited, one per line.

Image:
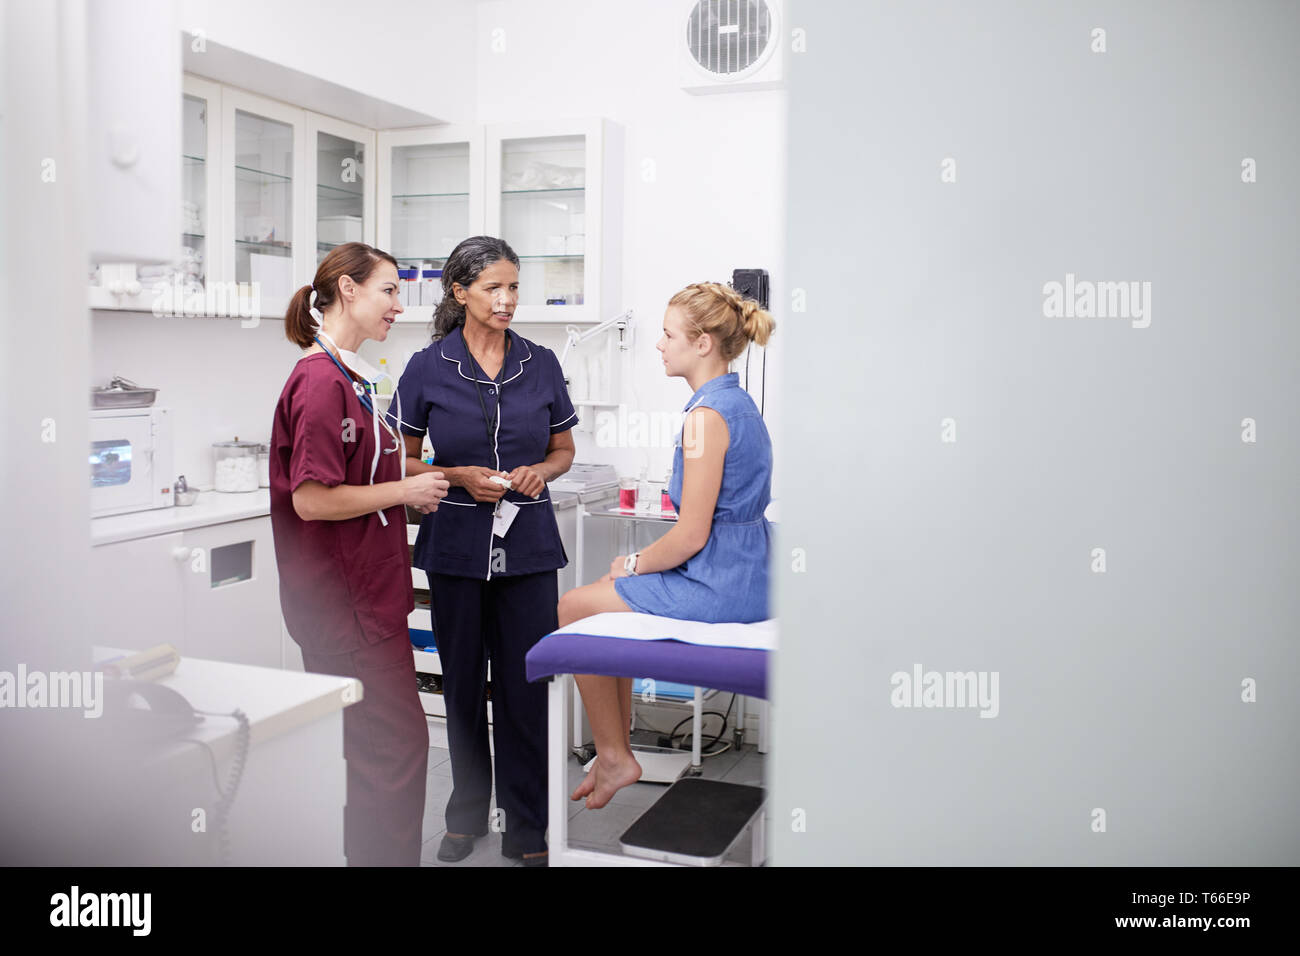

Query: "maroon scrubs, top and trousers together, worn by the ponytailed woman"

xmin=270 ymin=352 xmax=429 ymax=866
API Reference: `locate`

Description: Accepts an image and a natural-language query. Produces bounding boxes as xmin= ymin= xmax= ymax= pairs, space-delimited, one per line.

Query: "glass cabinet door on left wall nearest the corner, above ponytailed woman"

xmin=306 ymin=113 xmax=374 ymax=265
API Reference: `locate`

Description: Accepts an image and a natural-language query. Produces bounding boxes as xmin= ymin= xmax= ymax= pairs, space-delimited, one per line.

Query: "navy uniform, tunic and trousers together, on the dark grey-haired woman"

xmin=398 ymin=326 xmax=577 ymax=855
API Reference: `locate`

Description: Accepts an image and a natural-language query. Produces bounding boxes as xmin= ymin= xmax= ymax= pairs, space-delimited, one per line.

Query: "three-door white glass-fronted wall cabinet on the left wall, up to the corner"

xmin=88 ymin=75 xmax=376 ymax=319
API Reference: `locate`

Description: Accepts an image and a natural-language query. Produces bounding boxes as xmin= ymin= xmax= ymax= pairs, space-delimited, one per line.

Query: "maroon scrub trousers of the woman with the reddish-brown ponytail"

xmin=299 ymin=635 xmax=429 ymax=866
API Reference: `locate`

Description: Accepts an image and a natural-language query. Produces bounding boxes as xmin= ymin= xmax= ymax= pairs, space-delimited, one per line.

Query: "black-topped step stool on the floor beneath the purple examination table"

xmin=619 ymin=777 xmax=763 ymax=866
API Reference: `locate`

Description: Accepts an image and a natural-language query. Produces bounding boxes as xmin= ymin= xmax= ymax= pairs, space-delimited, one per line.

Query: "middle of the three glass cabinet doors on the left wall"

xmin=222 ymin=88 xmax=309 ymax=317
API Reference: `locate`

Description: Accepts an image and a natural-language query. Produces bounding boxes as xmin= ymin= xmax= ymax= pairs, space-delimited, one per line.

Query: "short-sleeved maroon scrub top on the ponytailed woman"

xmin=263 ymin=352 xmax=415 ymax=654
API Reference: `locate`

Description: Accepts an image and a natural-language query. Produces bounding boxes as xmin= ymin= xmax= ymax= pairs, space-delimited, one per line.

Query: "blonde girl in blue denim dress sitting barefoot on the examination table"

xmin=559 ymin=282 xmax=776 ymax=809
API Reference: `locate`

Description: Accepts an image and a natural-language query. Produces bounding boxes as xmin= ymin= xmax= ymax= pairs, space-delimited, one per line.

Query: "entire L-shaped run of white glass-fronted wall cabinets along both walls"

xmin=90 ymin=87 xmax=624 ymax=325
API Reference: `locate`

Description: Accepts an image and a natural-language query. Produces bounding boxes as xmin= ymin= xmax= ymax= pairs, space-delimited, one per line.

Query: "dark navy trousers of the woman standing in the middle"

xmin=429 ymin=571 xmax=559 ymax=856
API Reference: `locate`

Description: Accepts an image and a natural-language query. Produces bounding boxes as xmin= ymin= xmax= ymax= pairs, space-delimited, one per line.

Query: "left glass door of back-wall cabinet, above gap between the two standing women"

xmin=377 ymin=126 xmax=484 ymax=323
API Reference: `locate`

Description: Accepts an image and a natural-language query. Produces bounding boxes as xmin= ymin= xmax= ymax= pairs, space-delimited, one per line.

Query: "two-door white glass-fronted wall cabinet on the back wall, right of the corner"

xmin=377 ymin=120 xmax=623 ymax=325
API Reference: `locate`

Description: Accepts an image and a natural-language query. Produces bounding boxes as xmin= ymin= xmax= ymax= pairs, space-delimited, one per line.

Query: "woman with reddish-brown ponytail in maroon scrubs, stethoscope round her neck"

xmin=270 ymin=242 xmax=447 ymax=866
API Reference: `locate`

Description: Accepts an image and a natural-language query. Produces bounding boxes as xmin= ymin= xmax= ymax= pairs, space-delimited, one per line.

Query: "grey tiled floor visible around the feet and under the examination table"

xmin=420 ymin=745 xmax=763 ymax=866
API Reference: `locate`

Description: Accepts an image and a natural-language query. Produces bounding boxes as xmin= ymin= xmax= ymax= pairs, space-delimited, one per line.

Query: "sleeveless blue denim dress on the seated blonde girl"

xmin=614 ymin=372 xmax=772 ymax=623
